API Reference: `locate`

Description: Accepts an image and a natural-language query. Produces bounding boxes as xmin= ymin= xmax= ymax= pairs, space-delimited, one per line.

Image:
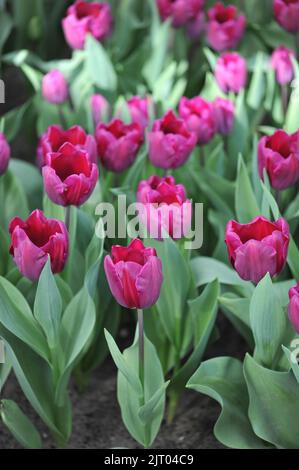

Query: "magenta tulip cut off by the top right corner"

xmin=273 ymin=0 xmax=299 ymax=33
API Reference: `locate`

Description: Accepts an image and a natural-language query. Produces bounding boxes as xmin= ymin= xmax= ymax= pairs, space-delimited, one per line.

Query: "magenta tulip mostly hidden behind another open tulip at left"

xmin=37 ymin=125 xmax=98 ymax=168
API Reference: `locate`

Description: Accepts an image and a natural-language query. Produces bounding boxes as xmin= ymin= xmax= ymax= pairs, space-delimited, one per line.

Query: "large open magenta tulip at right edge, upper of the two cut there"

xmin=258 ymin=130 xmax=299 ymax=189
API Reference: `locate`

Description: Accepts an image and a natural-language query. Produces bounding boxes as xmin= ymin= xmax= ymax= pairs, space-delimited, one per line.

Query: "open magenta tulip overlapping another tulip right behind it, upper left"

xmin=42 ymin=142 xmax=99 ymax=206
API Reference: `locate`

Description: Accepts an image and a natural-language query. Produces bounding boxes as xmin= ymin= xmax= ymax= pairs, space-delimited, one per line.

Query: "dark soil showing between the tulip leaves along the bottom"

xmin=0 ymin=317 xmax=245 ymax=449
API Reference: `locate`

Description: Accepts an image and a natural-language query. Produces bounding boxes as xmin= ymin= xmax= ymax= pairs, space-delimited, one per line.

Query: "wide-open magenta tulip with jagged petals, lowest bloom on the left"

xmin=9 ymin=210 xmax=69 ymax=281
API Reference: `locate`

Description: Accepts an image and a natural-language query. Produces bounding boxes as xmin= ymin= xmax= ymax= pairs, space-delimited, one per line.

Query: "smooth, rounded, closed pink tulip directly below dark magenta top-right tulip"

xmin=215 ymin=52 xmax=247 ymax=93
